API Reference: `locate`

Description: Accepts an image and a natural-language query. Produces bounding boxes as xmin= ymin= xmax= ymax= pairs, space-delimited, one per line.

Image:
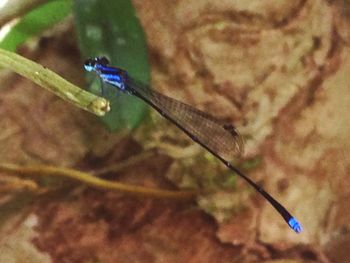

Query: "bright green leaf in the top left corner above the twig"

xmin=0 ymin=0 xmax=71 ymax=51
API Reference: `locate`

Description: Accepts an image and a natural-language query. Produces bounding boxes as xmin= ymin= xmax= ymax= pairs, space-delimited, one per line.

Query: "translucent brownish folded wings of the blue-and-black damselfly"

xmin=127 ymin=78 xmax=244 ymax=161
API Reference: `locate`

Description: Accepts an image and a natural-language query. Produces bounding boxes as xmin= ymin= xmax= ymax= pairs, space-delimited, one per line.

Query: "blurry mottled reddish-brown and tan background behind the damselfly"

xmin=0 ymin=0 xmax=350 ymax=263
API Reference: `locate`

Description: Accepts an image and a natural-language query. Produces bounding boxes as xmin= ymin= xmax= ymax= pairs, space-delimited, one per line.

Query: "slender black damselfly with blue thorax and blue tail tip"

xmin=84 ymin=57 xmax=302 ymax=233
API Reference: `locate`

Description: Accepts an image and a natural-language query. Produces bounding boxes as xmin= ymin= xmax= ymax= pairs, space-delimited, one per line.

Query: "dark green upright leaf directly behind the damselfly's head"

xmin=73 ymin=0 xmax=150 ymax=131
